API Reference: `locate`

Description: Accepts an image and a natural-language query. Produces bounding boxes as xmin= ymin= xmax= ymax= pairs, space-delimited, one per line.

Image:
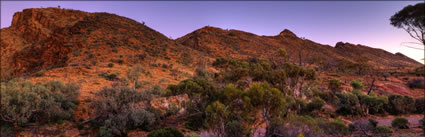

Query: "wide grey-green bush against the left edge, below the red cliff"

xmin=0 ymin=79 xmax=79 ymax=128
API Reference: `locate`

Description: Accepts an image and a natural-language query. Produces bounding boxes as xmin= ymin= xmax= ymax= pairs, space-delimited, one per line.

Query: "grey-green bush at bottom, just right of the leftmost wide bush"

xmin=90 ymin=87 xmax=157 ymax=136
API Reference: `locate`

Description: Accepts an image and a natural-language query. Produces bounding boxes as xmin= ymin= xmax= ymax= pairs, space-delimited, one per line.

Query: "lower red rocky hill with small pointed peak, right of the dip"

xmin=177 ymin=27 xmax=420 ymax=68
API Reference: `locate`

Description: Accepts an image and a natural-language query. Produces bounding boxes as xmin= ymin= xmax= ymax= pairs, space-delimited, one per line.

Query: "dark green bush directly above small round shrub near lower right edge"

xmin=385 ymin=95 xmax=415 ymax=115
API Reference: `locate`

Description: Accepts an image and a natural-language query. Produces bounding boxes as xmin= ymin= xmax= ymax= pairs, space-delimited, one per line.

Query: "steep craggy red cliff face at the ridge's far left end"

xmin=6 ymin=8 xmax=89 ymax=75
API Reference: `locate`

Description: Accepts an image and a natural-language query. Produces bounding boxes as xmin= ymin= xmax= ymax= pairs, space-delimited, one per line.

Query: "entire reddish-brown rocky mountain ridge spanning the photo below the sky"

xmin=1 ymin=8 xmax=421 ymax=80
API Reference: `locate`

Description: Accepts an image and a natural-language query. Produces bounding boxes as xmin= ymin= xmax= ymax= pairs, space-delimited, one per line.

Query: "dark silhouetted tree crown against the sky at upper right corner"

xmin=390 ymin=3 xmax=425 ymax=45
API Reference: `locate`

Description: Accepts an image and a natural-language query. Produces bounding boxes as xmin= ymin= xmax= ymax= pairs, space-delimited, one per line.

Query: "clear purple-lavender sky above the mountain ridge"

xmin=1 ymin=1 xmax=424 ymax=62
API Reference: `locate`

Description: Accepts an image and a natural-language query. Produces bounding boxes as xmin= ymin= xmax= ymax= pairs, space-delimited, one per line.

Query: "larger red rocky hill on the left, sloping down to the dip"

xmin=1 ymin=8 xmax=197 ymax=76
